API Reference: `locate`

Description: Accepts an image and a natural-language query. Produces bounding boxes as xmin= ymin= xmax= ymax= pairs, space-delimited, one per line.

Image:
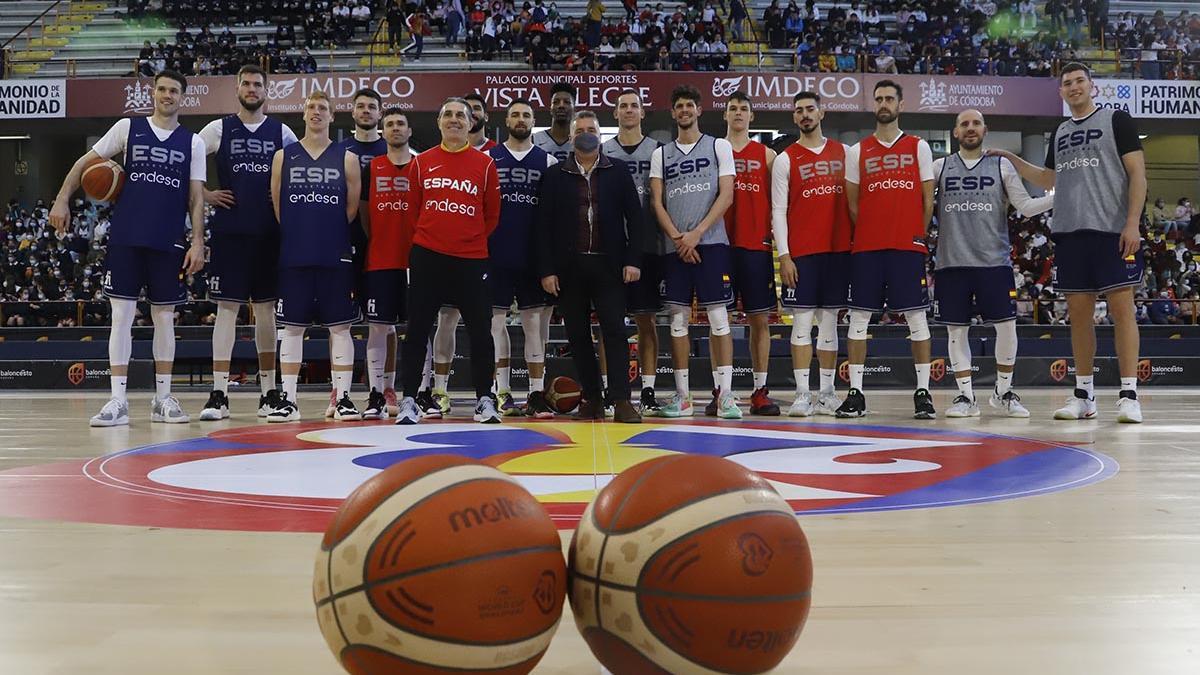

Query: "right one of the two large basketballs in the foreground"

xmin=568 ymin=455 xmax=812 ymax=675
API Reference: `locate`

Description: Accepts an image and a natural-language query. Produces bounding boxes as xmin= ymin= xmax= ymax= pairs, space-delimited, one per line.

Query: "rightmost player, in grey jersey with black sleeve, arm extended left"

xmin=996 ymin=62 xmax=1146 ymax=424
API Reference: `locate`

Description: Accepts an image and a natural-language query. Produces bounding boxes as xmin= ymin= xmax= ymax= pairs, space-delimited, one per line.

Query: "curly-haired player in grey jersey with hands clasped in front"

xmin=650 ymin=85 xmax=742 ymax=419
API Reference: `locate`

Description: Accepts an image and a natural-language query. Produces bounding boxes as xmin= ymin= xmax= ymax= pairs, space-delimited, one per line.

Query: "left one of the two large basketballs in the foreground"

xmin=313 ymin=455 xmax=566 ymax=675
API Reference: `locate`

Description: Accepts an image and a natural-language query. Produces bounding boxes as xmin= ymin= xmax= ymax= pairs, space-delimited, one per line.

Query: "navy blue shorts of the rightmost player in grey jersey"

xmin=1054 ymin=231 xmax=1142 ymax=293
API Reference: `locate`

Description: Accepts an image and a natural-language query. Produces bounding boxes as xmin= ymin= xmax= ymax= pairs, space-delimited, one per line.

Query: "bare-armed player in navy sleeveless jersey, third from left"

xmin=266 ymin=91 xmax=361 ymax=422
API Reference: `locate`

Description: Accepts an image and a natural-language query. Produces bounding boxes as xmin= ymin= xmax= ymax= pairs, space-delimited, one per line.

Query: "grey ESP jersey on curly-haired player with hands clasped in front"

xmin=660 ymin=133 xmax=730 ymax=246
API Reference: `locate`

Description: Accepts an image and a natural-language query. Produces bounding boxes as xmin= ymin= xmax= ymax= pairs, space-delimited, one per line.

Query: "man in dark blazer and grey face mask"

xmin=533 ymin=110 xmax=646 ymax=423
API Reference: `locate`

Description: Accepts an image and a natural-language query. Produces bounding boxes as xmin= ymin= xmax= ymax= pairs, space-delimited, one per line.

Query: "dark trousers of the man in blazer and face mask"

xmin=558 ymin=255 xmax=629 ymax=401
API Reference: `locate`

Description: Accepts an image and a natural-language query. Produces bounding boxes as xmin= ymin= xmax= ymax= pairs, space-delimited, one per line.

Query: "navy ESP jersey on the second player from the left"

xmin=211 ymin=115 xmax=283 ymax=237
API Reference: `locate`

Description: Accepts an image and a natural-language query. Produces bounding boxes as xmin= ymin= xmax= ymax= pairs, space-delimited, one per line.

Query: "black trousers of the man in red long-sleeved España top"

xmin=400 ymin=245 xmax=496 ymax=399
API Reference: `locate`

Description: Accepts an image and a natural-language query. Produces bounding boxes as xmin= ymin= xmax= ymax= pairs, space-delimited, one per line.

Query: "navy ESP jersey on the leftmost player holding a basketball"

xmin=109 ymin=118 xmax=193 ymax=251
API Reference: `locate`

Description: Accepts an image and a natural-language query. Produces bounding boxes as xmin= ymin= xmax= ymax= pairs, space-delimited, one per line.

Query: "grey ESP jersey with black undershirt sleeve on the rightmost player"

xmin=1046 ymin=108 xmax=1141 ymax=234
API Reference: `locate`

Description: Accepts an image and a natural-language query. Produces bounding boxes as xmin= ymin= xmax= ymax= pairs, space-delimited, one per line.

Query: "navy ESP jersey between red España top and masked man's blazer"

xmin=487 ymin=145 xmax=550 ymax=270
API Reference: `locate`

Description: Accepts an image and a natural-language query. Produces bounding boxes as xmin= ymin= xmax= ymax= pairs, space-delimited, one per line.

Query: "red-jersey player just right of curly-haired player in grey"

xmin=720 ymin=91 xmax=779 ymax=417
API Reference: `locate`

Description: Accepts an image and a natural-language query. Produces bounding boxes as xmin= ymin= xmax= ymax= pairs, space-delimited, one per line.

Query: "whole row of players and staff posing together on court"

xmin=50 ymin=64 xmax=1146 ymax=426
